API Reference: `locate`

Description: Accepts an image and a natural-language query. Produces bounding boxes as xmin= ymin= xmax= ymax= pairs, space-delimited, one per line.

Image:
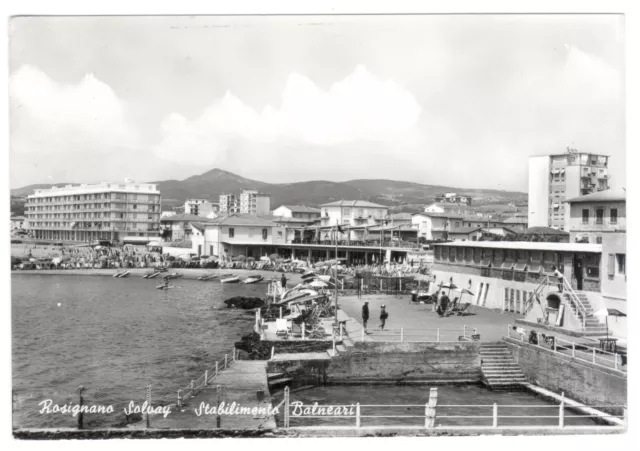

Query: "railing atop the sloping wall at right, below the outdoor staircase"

xmin=507 ymin=324 xmax=627 ymax=372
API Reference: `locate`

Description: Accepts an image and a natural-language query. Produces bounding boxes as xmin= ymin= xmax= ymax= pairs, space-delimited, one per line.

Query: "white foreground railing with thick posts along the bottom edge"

xmin=282 ymin=387 xmax=627 ymax=429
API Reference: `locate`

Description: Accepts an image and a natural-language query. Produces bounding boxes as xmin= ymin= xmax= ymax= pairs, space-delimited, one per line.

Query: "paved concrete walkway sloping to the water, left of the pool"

xmin=151 ymin=360 xmax=276 ymax=430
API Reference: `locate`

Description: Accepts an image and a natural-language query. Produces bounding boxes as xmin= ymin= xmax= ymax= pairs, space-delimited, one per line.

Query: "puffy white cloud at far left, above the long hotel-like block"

xmin=9 ymin=65 xmax=139 ymax=158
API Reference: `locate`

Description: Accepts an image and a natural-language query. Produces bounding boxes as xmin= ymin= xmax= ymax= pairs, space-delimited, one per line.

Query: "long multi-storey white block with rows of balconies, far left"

xmin=25 ymin=182 xmax=161 ymax=241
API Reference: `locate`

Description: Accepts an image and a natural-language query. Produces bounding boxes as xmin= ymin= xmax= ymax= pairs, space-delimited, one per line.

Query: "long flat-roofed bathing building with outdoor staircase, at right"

xmin=432 ymin=241 xmax=626 ymax=336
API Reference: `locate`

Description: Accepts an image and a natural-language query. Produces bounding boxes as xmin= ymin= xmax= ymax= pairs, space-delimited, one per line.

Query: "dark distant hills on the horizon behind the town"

xmin=11 ymin=169 xmax=527 ymax=210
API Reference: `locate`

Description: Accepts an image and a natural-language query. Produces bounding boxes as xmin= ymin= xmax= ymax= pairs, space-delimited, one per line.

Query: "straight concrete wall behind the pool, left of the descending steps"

xmin=326 ymin=342 xmax=482 ymax=383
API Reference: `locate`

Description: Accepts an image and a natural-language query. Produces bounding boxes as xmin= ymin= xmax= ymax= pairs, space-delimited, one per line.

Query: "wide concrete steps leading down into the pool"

xmin=480 ymin=342 xmax=527 ymax=390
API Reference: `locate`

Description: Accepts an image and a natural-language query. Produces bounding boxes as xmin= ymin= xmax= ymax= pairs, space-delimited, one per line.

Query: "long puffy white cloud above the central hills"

xmin=155 ymin=66 xmax=421 ymax=164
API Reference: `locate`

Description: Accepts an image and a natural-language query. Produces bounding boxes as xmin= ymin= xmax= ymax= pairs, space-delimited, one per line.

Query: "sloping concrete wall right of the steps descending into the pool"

xmin=505 ymin=338 xmax=627 ymax=406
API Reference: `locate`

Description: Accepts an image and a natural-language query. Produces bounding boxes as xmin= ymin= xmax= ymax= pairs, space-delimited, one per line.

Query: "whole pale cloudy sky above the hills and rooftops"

xmin=9 ymin=15 xmax=626 ymax=191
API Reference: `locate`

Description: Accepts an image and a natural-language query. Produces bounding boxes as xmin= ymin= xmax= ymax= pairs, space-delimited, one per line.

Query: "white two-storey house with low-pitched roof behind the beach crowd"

xmin=191 ymin=214 xmax=286 ymax=260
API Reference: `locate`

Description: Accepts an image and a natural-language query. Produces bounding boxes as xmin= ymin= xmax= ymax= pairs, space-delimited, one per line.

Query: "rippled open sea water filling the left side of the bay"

xmin=11 ymin=275 xmax=266 ymax=427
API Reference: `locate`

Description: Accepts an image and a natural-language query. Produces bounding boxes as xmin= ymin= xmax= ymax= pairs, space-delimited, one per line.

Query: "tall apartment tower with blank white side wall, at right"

xmin=529 ymin=148 xmax=609 ymax=230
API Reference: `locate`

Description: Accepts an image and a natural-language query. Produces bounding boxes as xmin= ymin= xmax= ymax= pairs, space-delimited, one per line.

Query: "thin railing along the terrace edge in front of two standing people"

xmin=353 ymin=324 xmax=480 ymax=343
